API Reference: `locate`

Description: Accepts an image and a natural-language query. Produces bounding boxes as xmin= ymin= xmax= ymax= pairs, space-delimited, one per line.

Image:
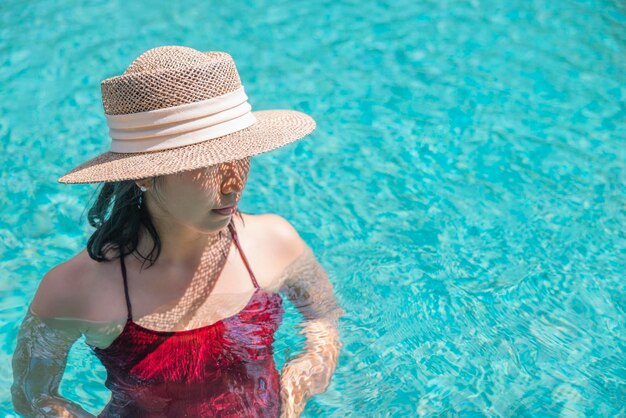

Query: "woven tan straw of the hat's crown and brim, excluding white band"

xmin=59 ymin=46 xmax=316 ymax=183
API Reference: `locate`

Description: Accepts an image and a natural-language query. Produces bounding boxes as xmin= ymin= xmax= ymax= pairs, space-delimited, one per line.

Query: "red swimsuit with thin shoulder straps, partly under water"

xmin=90 ymin=221 xmax=284 ymax=418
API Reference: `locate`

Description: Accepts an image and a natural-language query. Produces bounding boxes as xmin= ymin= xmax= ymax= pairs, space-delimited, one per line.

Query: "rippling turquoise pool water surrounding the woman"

xmin=0 ymin=0 xmax=626 ymax=417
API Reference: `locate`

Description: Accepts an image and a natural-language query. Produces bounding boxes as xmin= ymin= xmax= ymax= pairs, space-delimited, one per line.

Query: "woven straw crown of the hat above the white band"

xmin=100 ymin=46 xmax=241 ymax=115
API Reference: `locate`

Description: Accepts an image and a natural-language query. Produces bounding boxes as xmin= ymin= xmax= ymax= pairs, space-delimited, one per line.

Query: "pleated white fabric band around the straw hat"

xmin=105 ymin=86 xmax=256 ymax=153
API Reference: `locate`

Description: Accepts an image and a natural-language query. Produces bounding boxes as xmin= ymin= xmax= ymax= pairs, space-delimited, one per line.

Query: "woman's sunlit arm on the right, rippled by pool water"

xmin=280 ymin=225 xmax=346 ymax=417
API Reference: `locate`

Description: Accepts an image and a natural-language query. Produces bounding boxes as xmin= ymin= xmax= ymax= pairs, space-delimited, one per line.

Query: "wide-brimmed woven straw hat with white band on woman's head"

xmin=59 ymin=46 xmax=315 ymax=183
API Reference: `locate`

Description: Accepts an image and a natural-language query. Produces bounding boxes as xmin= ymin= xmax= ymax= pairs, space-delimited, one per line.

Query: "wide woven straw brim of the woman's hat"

xmin=58 ymin=109 xmax=316 ymax=184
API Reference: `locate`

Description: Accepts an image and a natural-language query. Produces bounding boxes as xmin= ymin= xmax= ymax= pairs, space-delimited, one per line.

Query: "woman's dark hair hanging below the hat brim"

xmin=87 ymin=177 xmax=243 ymax=267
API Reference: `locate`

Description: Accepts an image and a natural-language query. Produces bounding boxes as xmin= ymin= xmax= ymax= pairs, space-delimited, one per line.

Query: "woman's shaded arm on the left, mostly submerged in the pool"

xmin=11 ymin=265 xmax=94 ymax=418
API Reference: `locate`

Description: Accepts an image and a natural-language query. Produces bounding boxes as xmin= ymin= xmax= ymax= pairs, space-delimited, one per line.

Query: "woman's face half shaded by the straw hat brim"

xmin=141 ymin=157 xmax=250 ymax=232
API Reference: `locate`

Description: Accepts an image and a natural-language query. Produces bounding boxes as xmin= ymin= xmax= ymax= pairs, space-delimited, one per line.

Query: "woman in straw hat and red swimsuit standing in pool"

xmin=12 ymin=46 xmax=345 ymax=417
